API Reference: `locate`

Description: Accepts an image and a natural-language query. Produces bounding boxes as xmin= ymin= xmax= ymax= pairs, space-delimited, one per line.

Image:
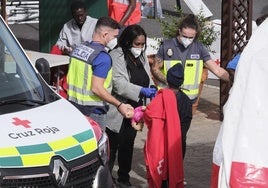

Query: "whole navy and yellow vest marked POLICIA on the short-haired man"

xmin=67 ymin=42 xmax=112 ymax=106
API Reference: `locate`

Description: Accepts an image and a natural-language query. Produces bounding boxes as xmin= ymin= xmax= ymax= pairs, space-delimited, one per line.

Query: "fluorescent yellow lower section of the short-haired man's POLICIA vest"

xmin=67 ymin=57 xmax=112 ymax=106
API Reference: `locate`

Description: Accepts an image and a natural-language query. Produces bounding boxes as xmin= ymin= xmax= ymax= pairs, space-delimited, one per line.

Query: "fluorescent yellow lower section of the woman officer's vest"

xmin=161 ymin=60 xmax=203 ymax=100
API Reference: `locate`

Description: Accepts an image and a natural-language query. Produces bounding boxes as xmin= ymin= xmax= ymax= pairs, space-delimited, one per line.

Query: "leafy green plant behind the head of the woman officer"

xmin=158 ymin=7 xmax=220 ymax=53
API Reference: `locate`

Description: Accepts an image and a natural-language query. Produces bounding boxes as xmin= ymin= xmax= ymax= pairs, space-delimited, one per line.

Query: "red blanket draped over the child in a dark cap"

xmin=144 ymin=89 xmax=184 ymax=188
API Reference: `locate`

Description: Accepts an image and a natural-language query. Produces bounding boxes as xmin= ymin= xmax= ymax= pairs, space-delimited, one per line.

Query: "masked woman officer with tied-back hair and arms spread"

xmin=152 ymin=14 xmax=229 ymax=109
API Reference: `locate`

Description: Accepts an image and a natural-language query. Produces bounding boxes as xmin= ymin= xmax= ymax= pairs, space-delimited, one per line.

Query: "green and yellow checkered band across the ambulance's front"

xmin=0 ymin=129 xmax=98 ymax=168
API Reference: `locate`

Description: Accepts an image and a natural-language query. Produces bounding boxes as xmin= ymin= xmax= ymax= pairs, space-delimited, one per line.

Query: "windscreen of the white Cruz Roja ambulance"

xmin=0 ymin=19 xmax=44 ymax=101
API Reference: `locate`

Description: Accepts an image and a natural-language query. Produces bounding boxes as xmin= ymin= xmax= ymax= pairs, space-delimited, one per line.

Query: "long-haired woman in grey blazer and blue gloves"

xmin=106 ymin=25 xmax=156 ymax=187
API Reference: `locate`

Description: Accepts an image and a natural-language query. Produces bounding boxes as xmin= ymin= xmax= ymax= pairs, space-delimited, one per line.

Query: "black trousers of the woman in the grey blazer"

xmin=106 ymin=119 xmax=137 ymax=182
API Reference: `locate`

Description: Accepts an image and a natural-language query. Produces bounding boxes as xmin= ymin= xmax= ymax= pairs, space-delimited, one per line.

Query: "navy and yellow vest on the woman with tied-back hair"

xmin=159 ymin=38 xmax=204 ymax=100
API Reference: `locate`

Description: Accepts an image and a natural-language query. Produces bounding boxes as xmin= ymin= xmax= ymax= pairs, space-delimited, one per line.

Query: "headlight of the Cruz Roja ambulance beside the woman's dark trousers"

xmin=98 ymin=133 xmax=110 ymax=165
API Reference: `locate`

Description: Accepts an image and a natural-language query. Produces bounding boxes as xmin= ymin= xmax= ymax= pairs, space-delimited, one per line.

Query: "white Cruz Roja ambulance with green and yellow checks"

xmin=0 ymin=17 xmax=112 ymax=188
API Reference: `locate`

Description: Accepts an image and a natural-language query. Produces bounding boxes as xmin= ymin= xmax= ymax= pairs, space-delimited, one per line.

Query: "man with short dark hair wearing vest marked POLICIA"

xmin=67 ymin=17 xmax=133 ymax=130
